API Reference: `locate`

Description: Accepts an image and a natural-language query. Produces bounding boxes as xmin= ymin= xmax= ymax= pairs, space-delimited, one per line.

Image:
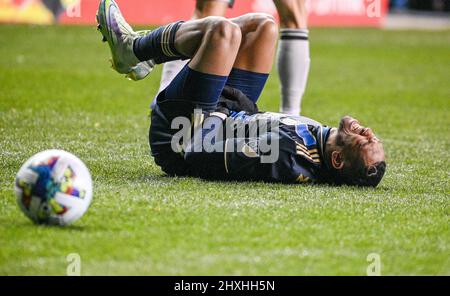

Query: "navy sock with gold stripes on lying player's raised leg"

xmin=133 ymin=21 xmax=184 ymax=64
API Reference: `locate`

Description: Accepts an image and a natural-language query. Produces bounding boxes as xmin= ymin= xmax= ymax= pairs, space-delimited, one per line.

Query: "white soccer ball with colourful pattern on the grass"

xmin=14 ymin=150 xmax=92 ymax=225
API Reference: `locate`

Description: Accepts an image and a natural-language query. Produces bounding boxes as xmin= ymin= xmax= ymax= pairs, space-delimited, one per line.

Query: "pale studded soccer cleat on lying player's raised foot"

xmin=97 ymin=0 xmax=155 ymax=81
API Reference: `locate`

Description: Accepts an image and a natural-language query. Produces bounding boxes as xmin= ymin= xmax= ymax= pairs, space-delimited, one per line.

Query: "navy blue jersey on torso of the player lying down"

xmin=184 ymin=111 xmax=330 ymax=183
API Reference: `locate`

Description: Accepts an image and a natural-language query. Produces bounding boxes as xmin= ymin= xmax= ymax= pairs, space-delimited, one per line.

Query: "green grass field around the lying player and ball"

xmin=0 ymin=25 xmax=450 ymax=275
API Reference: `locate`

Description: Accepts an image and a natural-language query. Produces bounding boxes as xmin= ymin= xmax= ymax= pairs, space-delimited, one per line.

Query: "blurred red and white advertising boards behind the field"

xmin=0 ymin=0 xmax=450 ymax=29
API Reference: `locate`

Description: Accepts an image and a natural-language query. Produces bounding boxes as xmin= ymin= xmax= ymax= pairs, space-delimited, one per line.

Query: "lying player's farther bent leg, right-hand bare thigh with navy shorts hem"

xmin=222 ymin=13 xmax=278 ymax=102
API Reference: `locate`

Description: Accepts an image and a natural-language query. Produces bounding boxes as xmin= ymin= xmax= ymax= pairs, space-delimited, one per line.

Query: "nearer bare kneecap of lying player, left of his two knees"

xmin=211 ymin=17 xmax=241 ymax=46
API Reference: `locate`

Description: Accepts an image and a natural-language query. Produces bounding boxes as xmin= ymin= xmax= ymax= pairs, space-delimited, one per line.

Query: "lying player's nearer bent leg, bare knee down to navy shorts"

xmin=157 ymin=17 xmax=241 ymax=115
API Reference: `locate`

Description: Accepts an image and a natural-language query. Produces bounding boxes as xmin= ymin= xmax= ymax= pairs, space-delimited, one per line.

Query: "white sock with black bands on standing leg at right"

xmin=277 ymin=29 xmax=311 ymax=115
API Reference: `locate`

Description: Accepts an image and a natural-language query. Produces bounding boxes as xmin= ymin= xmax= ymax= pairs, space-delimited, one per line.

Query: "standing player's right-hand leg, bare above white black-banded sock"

xmin=273 ymin=0 xmax=310 ymax=115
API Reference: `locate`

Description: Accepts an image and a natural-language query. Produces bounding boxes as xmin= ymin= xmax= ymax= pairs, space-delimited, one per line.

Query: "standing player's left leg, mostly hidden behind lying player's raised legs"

xmin=157 ymin=0 xmax=230 ymax=95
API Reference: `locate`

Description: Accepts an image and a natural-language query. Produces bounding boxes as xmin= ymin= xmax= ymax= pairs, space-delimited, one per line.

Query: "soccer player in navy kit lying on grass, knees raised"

xmin=97 ymin=0 xmax=386 ymax=187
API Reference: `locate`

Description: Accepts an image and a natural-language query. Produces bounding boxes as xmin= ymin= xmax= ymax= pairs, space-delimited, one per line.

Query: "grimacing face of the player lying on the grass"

xmin=337 ymin=116 xmax=385 ymax=166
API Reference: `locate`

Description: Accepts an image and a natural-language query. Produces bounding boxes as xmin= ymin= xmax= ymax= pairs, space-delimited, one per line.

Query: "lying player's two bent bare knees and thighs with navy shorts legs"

xmin=160 ymin=13 xmax=278 ymax=111
